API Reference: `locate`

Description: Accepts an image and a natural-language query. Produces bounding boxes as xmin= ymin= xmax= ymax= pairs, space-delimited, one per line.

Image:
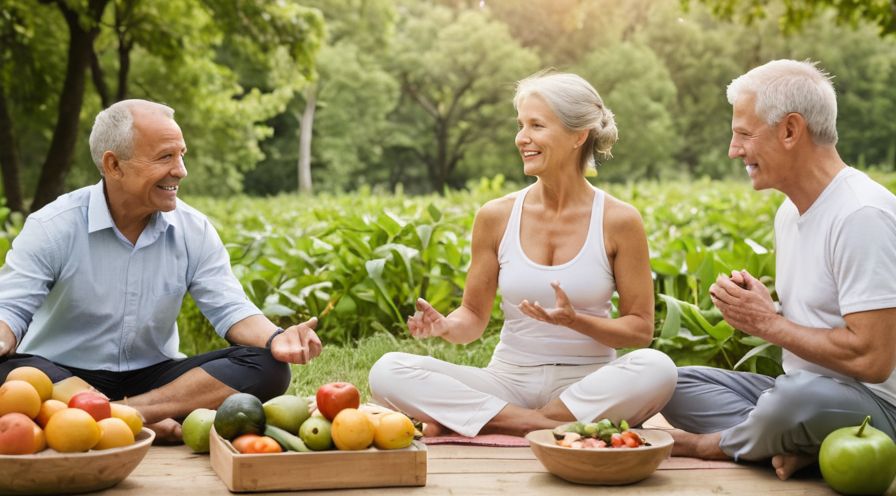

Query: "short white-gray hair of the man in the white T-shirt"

xmin=727 ymin=59 xmax=837 ymax=145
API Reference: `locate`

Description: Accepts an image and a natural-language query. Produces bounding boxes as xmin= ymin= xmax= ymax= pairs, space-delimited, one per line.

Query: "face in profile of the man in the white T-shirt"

xmin=728 ymin=94 xmax=784 ymax=190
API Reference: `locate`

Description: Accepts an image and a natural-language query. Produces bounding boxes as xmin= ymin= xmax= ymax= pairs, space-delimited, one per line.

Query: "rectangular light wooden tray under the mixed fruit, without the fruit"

xmin=209 ymin=428 xmax=426 ymax=492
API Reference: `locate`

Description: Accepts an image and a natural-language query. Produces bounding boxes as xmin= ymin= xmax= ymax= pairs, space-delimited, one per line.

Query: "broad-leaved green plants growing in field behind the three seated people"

xmin=173 ymin=176 xmax=812 ymax=376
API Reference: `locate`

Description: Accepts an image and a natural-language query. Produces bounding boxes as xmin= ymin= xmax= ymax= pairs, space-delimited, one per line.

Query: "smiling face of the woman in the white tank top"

xmin=516 ymin=95 xmax=587 ymax=176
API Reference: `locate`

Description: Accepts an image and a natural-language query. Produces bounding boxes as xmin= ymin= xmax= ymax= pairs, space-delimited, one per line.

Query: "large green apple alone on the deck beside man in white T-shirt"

xmin=818 ymin=416 xmax=896 ymax=494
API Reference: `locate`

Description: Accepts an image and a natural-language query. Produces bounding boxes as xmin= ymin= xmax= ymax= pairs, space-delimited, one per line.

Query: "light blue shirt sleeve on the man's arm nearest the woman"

xmin=189 ymin=220 xmax=262 ymax=338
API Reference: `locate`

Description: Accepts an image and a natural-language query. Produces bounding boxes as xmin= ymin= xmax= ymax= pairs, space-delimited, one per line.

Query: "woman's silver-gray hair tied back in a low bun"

xmin=513 ymin=72 xmax=618 ymax=171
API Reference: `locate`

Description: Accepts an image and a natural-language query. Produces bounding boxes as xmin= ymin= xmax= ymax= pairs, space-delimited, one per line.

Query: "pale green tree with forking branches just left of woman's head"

xmin=389 ymin=5 xmax=538 ymax=192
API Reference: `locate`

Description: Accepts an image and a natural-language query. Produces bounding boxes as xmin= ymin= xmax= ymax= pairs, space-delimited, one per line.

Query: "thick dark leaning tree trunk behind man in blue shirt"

xmin=31 ymin=0 xmax=108 ymax=212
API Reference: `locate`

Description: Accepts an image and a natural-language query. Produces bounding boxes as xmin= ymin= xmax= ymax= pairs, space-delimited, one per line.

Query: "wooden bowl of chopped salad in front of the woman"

xmin=526 ymin=419 xmax=672 ymax=485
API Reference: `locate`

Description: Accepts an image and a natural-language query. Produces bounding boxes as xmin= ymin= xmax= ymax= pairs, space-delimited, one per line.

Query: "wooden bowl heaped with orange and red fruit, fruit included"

xmin=0 ymin=367 xmax=155 ymax=494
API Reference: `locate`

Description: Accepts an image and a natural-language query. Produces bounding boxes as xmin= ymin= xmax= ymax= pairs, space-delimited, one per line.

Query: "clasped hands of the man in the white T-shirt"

xmin=709 ymin=270 xmax=778 ymax=338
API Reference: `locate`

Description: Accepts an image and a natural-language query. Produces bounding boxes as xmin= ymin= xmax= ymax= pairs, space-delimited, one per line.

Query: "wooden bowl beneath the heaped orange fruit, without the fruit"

xmin=0 ymin=427 xmax=156 ymax=494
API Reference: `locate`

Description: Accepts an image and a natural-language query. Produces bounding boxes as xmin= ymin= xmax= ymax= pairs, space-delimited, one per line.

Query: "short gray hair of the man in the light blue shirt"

xmin=90 ymin=99 xmax=174 ymax=176
